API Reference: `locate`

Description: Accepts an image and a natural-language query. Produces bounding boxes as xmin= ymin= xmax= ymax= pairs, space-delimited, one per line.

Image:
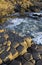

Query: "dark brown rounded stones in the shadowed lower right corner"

xmin=2 ymin=44 xmax=42 ymax=65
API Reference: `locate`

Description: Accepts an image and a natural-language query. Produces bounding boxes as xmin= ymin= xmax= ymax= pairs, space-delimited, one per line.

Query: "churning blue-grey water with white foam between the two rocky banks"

xmin=1 ymin=12 xmax=42 ymax=44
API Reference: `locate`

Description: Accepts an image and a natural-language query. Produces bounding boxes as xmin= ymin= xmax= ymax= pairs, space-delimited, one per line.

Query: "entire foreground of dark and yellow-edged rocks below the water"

xmin=0 ymin=30 xmax=42 ymax=65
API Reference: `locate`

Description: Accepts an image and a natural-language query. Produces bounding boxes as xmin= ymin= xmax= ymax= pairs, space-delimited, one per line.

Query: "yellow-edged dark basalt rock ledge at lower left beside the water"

xmin=0 ymin=30 xmax=32 ymax=64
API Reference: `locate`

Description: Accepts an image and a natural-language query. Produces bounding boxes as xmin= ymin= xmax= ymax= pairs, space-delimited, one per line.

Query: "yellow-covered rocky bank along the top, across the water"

xmin=0 ymin=0 xmax=42 ymax=22
